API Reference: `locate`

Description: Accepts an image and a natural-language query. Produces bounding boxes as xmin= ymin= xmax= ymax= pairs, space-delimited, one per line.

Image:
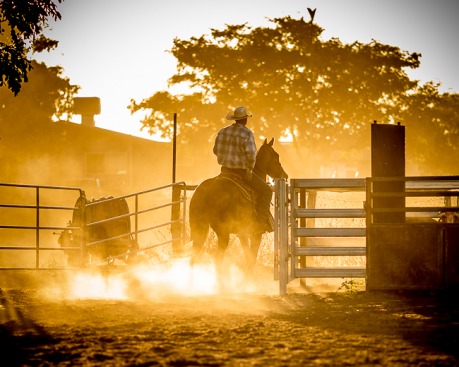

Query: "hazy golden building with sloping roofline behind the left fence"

xmin=0 ymin=121 xmax=172 ymax=197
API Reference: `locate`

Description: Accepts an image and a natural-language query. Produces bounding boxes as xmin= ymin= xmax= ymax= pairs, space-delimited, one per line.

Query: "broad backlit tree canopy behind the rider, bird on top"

xmin=130 ymin=16 xmax=457 ymax=177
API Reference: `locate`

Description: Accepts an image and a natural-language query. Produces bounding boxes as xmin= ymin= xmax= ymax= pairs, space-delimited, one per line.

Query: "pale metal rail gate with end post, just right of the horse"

xmin=274 ymin=179 xmax=366 ymax=294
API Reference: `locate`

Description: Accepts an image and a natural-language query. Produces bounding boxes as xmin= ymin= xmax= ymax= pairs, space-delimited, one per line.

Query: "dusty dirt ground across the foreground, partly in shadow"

xmin=0 ymin=268 xmax=459 ymax=366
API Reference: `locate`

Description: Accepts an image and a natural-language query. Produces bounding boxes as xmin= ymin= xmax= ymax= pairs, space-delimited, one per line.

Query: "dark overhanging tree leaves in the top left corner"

xmin=0 ymin=0 xmax=62 ymax=95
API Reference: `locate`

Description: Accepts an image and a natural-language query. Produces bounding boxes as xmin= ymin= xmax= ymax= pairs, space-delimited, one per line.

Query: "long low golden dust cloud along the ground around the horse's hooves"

xmin=12 ymin=258 xmax=278 ymax=302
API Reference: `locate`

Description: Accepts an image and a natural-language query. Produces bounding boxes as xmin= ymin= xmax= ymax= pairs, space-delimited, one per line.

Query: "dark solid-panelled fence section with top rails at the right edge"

xmin=366 ymin=176 xmax=459 ymax=291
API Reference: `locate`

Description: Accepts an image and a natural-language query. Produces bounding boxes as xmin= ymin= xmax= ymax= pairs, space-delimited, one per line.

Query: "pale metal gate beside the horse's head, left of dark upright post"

xmin=274 ymin=179 xmax=366 ymax=294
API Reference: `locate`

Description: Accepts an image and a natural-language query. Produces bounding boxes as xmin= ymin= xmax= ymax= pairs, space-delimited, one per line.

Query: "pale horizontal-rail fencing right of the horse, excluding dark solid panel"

xmin=274 ymin=176 xmax=459 ymax=294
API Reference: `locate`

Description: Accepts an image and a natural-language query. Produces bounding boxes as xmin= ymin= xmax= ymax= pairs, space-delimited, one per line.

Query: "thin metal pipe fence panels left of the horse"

xmin=0 ymin=182 xmax=187 ymax=270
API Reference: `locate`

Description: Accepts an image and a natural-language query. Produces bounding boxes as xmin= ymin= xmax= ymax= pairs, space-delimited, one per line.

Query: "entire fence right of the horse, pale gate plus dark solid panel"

xmin=274 ymin=176 xmax=459 ymax=294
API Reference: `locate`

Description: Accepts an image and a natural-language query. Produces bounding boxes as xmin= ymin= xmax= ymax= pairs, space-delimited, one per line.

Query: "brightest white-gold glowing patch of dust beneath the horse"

xmin=65 ymin=259 xmax=253 ymax=300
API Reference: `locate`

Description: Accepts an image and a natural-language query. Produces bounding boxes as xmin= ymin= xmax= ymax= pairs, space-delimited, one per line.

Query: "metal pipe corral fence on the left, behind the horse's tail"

xmin=0 ymin=182 xmax=186 ymax=270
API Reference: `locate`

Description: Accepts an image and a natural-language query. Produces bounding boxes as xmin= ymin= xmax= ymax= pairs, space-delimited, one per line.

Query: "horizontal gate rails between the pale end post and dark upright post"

xmin=290 ymin=179 xmax=366 ymax=290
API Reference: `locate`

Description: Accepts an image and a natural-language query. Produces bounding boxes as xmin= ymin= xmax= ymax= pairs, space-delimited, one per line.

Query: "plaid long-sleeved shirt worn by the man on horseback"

xmin=214 ymin=123 xmax=257 ymax=170
